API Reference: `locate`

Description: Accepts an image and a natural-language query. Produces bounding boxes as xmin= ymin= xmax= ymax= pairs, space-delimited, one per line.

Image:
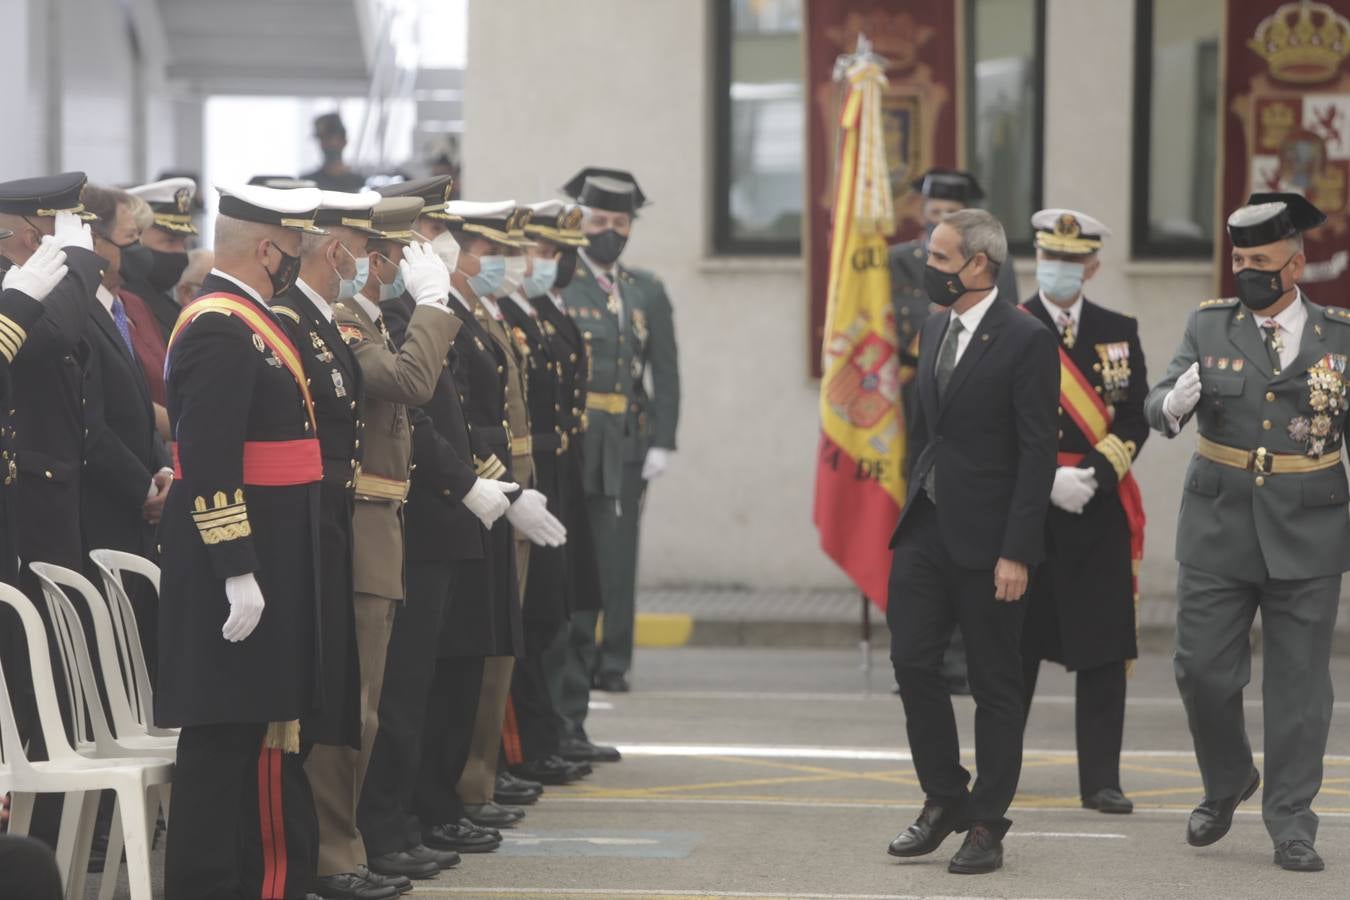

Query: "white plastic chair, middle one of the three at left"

xmin=30 ymin=563 xmax=178 ymax=900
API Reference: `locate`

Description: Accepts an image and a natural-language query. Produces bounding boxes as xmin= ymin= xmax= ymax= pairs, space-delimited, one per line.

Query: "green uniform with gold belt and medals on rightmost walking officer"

xmin=1145 ymin=291 xmax=1350 ymax=845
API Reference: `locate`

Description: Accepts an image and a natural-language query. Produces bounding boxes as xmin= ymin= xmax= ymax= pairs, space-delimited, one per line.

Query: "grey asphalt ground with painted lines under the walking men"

xmin=89 ymin=648 xmax=1350 ymax=900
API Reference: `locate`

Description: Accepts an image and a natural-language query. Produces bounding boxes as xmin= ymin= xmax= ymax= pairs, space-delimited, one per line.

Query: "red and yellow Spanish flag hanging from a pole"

xmin=815 ymin=55 xmax=905 ymax=609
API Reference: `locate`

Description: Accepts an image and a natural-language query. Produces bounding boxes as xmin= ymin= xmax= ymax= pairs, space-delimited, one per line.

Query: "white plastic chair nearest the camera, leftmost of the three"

xmin=0 ymin=584 xmax=173 ymax=900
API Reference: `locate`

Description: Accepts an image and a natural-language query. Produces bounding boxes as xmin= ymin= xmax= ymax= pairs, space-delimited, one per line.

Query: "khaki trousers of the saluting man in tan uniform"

xmin=305 ymin=594 xmax=398 ymax=877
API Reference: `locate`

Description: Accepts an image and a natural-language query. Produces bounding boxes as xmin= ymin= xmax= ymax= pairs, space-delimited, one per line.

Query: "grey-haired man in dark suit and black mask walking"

xmin=887 ymin=209 xmax=1060 ymax=874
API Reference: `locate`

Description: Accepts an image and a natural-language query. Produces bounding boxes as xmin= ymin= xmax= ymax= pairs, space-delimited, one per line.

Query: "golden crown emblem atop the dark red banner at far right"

xmin=1247 ymin=0 xmax=1350 ymax=84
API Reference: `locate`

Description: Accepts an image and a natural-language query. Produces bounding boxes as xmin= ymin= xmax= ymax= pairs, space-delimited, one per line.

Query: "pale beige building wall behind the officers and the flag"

xmin=464 ymin=0 xmax=1212 ymax=594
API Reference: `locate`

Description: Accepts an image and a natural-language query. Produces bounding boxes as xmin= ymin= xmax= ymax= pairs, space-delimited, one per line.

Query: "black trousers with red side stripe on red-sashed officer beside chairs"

xmin=165 ymin=723 xmax=319 ymax=900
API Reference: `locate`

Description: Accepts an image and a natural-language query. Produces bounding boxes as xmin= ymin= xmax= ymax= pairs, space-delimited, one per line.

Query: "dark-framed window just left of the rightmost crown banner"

xmin=1130 ymin=0 xmax=1223 ymax=259
